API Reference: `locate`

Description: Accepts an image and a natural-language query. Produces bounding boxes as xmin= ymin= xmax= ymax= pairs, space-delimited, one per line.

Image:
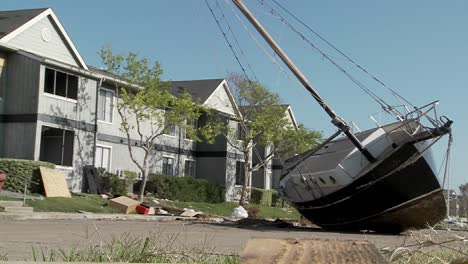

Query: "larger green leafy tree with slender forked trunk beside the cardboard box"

xmin=98 ymin=47 xmax=222 ymax=201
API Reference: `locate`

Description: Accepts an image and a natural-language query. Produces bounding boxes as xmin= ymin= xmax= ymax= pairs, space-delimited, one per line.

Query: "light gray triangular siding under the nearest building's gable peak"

xmin=8 ymin=16 xmax=78 ymax=66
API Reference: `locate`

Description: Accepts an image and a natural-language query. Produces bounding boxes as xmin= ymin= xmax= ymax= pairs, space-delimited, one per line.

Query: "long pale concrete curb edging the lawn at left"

xmin=0 ymin=212 xmax=195 ymax=222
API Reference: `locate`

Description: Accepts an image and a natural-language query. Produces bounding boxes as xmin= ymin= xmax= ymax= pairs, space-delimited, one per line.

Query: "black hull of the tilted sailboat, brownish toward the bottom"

xmin=293 ymin=144 xmax=446 ymax=232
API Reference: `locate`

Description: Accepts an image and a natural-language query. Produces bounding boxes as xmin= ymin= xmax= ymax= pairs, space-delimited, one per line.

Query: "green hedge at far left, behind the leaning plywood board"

xmin=0 ymin=159 xmax=55 ymax=193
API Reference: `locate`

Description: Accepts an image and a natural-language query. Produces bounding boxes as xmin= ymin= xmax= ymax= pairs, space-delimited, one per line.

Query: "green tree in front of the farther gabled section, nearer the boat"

xmin=226 ymin=73 xmax=288 ymax=205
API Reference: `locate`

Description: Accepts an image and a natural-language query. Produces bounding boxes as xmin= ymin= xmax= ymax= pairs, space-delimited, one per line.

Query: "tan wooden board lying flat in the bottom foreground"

xmin=241 ymin=238 xmax=388 ymax=264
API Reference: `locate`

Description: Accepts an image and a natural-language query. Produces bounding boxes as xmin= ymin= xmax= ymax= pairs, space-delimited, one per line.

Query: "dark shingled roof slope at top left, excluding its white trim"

xmin=0 ymin=8 xmax=48 ymax=39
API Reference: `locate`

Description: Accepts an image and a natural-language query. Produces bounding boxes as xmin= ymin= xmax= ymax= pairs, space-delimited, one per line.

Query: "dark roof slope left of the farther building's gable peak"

xmin=171 ymin=79 xmax=224 ymax=103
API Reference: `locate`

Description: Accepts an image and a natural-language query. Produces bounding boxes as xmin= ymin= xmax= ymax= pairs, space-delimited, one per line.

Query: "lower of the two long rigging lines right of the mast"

xmin=257 ymin=0 xmax=391 ymax=111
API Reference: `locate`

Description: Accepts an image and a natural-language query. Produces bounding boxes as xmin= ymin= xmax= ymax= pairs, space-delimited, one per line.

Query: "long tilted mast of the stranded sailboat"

xmin=232 ymin=0 xmax=376 ymax=162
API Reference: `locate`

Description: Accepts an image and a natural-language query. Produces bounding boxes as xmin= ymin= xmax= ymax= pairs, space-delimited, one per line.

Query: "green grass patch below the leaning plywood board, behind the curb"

xmin=0 ymin=194 xmax=118 ymax=213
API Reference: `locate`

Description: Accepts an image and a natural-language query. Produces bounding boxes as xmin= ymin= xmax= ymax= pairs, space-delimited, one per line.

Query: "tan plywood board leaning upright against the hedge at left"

xmin=39 ymin=167 xmax=71 ymax=198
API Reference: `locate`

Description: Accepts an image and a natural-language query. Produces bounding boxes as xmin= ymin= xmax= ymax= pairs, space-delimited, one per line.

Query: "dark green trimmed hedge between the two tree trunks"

xmin=146 ymin=174 xmax=224 ymax=203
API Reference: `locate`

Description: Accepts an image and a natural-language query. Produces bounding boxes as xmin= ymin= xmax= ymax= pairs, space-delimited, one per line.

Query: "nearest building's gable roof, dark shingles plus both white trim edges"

xmin=0 ymin=8 xmax=88 ymax=70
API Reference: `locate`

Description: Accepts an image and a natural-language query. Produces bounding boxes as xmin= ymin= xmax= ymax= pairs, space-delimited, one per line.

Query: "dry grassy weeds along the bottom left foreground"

xmin=32 ymin=232 xmax=239 ymax=264
